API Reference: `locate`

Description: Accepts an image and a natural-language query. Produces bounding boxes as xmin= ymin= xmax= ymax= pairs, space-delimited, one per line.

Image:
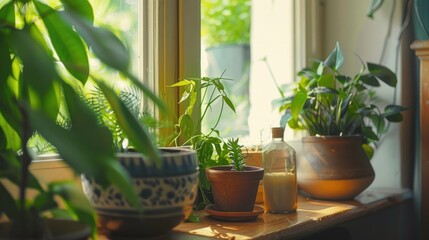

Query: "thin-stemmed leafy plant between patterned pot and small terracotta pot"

xmin=171 ymin=76 xmax=235 ymax=210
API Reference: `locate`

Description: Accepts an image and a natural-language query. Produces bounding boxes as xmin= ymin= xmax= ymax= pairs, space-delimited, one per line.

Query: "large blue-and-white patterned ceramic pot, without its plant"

xmin=82 ymin=148 xmax=198 ymax=237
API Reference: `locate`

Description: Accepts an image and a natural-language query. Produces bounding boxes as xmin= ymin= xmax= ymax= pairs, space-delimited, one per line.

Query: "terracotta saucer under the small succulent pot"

xmin=204 ymin=204 xmax=265 ymax=222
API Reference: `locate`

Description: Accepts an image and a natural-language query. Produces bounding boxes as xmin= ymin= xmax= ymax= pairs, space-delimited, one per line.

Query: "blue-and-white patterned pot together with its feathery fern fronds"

xmin=77 ymin=88 xmax=199 ymax=238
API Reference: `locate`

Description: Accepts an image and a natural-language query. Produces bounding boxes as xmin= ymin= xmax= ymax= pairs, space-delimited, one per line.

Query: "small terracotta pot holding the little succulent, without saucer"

xmin=206 ymin=166 xmax=264 ymax=212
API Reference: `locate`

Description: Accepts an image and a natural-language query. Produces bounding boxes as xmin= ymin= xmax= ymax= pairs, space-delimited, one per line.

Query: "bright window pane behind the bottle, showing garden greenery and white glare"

xmin=201 ymin=0 xmax=295 ymax=144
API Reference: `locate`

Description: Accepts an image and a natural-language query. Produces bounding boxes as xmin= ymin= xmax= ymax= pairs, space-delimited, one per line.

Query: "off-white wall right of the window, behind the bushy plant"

xmin=322 ymin=0 xmax=402 ymax=187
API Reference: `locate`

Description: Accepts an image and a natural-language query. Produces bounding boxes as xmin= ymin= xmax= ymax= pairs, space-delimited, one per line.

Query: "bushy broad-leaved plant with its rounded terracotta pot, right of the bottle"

xmin=281 ymin=43 xmax=405 ymax=200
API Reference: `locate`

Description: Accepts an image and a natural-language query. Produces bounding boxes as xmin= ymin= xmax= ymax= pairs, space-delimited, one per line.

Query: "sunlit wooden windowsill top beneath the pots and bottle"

xmin=170 ymin=189 xmax=412 ymax=240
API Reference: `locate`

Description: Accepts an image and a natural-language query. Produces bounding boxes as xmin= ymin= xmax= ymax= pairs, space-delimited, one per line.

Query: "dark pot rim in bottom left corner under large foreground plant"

xmin=0 ymin=219 xmax=91 ymax=240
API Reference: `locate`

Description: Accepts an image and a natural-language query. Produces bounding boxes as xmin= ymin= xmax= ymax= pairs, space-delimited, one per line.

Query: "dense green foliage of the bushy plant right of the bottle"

xmin=280 ymin=43 xmax=405 ymax=157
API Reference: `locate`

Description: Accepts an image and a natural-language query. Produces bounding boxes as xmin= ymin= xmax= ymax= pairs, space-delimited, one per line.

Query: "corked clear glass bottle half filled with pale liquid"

xmin=262 ymin=127 xmax=298 ymax=213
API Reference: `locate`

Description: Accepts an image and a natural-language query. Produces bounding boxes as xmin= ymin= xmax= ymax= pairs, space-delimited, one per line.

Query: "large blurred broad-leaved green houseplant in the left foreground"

xmin=0 ymin=0 xmax=163 ymax=239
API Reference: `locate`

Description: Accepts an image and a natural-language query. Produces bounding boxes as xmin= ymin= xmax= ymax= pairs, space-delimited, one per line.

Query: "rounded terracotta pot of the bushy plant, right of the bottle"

xmin=297 ymin=135 xmax=375 ymax=200
